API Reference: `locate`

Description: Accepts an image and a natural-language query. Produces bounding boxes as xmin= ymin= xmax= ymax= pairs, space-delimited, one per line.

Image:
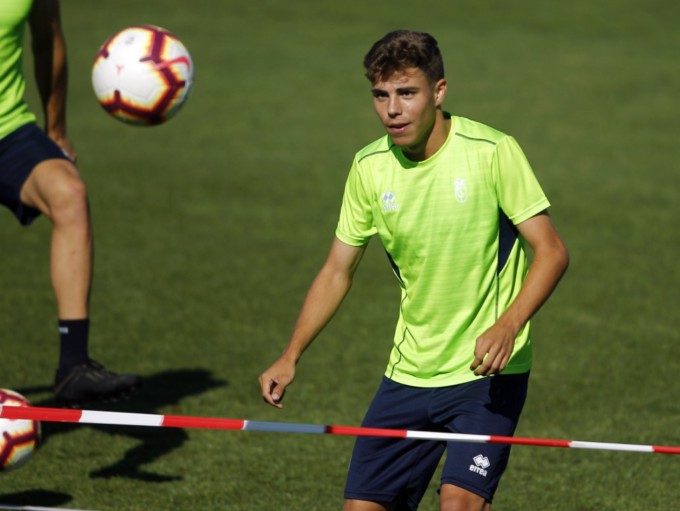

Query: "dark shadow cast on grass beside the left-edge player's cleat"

xmin=17 ymin=369 xmax=228 ymax=483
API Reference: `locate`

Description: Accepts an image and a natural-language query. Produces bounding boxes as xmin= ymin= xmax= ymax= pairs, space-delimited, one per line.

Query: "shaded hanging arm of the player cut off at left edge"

xmin=28 ymin=0 xmax=76 ymax=161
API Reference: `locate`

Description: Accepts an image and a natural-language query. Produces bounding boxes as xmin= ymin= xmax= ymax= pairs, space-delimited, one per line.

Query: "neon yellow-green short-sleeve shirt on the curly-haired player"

xmin=336 ymin=114 xmax=550 ymax=387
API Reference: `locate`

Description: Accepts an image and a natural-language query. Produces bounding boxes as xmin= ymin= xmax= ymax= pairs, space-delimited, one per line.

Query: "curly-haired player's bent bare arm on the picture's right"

xmin=470 ymin=211 xmax=569 ymax=376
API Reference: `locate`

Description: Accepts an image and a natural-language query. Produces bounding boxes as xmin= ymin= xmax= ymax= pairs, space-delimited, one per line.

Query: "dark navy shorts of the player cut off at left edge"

xmin=0 ymin=123 xmax=69 ymax=225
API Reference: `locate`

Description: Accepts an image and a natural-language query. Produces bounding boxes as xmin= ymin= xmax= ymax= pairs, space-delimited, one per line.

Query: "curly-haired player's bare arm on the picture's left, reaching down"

xmin=260 ymin=238 xmax=366 ymax=408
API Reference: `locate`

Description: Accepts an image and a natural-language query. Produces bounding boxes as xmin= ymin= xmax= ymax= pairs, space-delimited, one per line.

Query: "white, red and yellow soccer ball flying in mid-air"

xmin=92 ymin=25 xmax=194 ymax=126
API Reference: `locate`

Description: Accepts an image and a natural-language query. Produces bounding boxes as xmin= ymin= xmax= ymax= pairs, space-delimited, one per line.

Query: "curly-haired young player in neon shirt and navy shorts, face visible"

xmin=260 ymin=30 xmax=568 ymax=511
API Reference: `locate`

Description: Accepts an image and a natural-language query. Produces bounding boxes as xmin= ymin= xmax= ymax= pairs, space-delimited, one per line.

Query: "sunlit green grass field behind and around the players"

xmin=0 ymin=0 xmax=680 ymax=511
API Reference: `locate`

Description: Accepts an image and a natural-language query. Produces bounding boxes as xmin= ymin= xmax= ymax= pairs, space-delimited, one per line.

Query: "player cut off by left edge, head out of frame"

xmin=0 ymin=0 xmax=140 ymax=405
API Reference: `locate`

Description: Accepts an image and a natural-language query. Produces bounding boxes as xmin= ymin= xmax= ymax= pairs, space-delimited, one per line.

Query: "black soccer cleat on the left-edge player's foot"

xmin=54 ymin=360 xmax=142 ymax=407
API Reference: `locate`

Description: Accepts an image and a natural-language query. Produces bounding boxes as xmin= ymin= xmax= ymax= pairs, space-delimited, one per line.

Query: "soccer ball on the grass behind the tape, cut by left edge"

xmin=0 ymin=389 xmax=40 ymax=471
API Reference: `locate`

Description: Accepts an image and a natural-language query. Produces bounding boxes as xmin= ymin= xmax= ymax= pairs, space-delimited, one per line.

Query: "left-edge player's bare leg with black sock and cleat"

xmin=21 ymin=159 xmax=141 ymax=405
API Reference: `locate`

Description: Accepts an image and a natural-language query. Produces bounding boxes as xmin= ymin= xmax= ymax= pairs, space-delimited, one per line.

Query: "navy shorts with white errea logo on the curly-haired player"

xmin=345 ymin=373 xmax=529 ymax=511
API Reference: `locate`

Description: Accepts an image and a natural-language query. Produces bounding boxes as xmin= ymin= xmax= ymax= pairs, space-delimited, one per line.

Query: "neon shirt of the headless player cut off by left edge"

xmin=0 ymin=0 xmax=36 ymax=138
